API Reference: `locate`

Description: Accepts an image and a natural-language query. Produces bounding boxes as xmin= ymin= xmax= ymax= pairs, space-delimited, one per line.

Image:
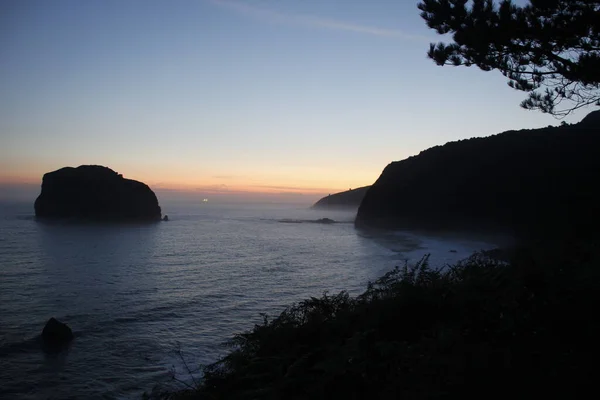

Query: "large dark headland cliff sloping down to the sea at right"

xmin=356 ymin=111 xmax=600 ymax=236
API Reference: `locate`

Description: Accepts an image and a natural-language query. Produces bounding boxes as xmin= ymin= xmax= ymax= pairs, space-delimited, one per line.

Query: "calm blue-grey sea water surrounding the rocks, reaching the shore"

xmin=0 ymin=203 xmax=493 ymax=399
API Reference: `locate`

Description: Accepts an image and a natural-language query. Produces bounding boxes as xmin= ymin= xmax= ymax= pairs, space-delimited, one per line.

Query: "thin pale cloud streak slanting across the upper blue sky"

xmin=208 ymin=0 xmax=431 ymax=42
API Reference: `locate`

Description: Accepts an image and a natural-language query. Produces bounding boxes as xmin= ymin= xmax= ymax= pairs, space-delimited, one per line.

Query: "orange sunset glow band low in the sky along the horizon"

xmin=0 ymin=159 xmax=380 ymax=197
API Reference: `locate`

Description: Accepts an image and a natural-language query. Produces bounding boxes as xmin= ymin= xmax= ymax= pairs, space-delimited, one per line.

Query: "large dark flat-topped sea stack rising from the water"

xmin=35 ymin=165 xmax=161 ymax=222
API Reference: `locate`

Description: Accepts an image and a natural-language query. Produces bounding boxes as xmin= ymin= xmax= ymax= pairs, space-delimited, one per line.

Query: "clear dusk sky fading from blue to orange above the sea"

xmin=0 ymin=0 xmax=591 ymax=202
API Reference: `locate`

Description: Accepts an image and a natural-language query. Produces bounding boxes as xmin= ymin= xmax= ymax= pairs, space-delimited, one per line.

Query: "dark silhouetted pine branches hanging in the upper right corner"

xmin=419 ymin=0 xmax=600 ymax=116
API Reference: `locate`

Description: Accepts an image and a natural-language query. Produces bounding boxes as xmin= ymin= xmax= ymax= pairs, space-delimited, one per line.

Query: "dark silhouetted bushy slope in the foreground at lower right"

xmin=159 ymin=239 xmax=600 ymax=400
